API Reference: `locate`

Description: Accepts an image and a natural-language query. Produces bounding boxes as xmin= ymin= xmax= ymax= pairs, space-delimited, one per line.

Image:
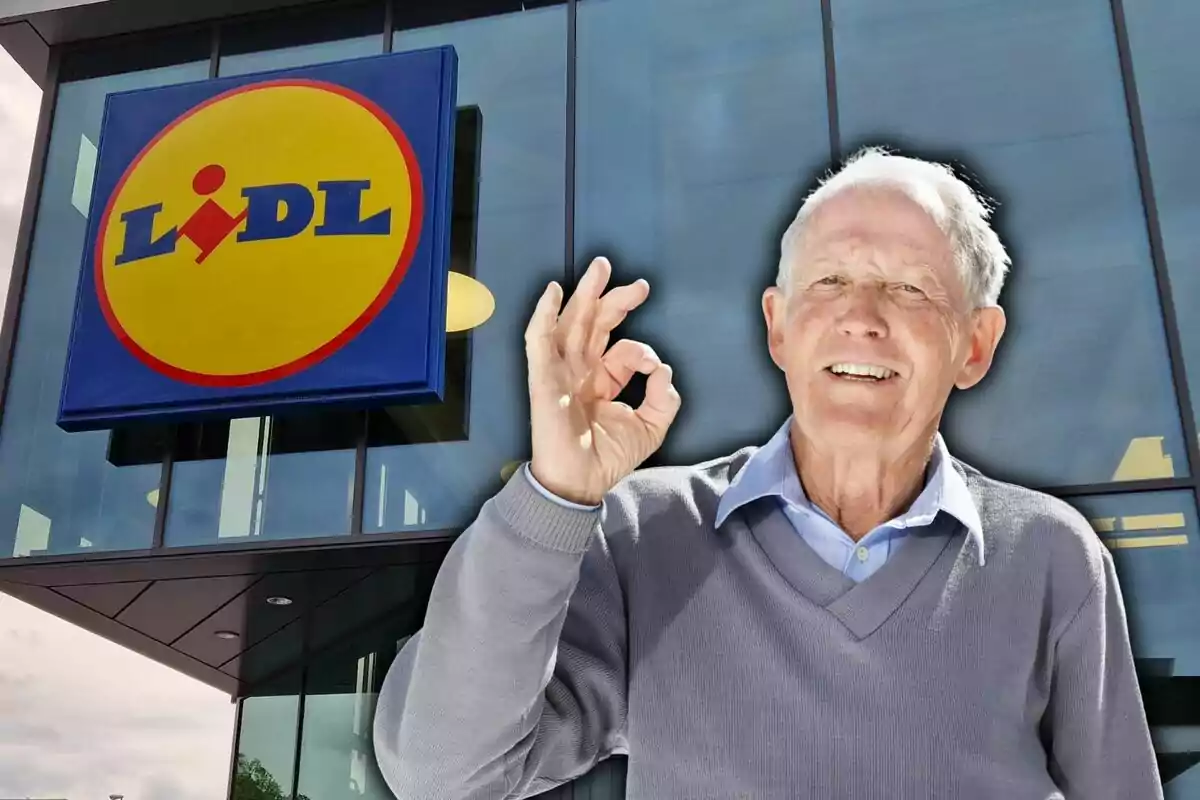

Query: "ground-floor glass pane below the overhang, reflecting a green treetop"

xmin=230 ymin=672 xmax=302 ymax=800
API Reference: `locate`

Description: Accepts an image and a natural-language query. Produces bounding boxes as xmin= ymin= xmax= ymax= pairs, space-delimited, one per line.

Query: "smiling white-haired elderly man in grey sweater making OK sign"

xmin=376 ymin=150 xmax=1162 ymax=800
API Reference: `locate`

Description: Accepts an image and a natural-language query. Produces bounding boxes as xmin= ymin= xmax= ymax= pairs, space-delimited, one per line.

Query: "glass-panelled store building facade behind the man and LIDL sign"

xmin=0 ymin=0 xmax=1200 ymax=800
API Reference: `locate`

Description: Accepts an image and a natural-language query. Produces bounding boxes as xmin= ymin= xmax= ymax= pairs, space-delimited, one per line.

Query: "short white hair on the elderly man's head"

xmin=776 ymin=148 xmax=1012 ymax=308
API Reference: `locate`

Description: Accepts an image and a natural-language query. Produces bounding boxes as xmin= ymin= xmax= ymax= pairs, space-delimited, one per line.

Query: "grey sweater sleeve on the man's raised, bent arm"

xmin=374 ymin=470 xmax=625 ymax=800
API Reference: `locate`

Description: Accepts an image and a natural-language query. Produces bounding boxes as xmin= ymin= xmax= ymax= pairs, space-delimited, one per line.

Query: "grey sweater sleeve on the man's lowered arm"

xmin=1046 ymin=551 xmax=1163 ymax=800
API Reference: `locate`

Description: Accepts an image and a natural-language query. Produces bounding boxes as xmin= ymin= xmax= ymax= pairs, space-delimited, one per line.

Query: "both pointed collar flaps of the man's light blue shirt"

xmin=716 ymin=417 xmax=984 ymax=563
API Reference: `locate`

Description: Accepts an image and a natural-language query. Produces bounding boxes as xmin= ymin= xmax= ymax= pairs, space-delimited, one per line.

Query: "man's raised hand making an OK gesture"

xmin=526 ymin=258 xmax=679 ymax=505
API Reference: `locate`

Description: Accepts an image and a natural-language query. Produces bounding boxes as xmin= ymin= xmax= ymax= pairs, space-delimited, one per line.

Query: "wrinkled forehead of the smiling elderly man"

xmin=797 ymin=186 xmax=958 ymax=279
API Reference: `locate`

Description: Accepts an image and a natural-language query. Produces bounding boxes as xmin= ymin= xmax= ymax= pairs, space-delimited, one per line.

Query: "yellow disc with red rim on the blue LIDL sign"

xmin=96 ymin=82 xmax=421 ymax=384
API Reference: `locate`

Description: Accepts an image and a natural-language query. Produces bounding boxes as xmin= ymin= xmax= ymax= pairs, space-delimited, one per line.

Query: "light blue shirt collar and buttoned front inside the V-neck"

xmin=716 ymin=417 xmax=983 ymax=582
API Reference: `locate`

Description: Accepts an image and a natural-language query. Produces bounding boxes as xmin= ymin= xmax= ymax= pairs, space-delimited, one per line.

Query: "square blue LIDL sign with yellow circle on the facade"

xmin=60 ymin=48 xmax=455 ymax=428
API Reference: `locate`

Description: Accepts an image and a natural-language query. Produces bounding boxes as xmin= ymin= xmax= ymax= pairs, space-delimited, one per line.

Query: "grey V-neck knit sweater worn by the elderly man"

xmin=374 ymin=449 xmax=1163 ymax=800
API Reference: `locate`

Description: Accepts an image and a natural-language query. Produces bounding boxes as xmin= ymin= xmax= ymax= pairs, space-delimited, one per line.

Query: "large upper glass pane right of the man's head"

xmin=833 ymin=0 xmax=1188 ymax=485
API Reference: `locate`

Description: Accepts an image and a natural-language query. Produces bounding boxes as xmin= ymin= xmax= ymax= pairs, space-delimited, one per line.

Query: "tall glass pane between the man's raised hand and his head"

xmin=575 ymin=0 xmax=829 ymax=463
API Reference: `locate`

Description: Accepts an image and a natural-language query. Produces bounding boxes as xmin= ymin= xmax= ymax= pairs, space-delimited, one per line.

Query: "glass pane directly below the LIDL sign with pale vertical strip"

xmin=164 ymin=410 xmax=364 ymax=546
